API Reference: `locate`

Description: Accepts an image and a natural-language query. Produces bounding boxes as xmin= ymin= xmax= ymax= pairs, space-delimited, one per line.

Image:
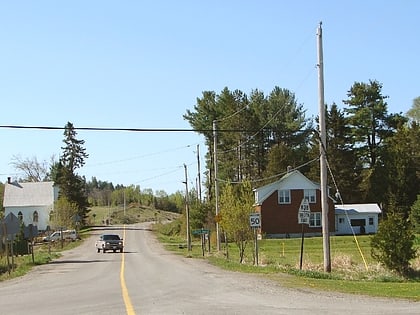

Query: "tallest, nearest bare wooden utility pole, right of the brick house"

xmin=317 ymin=22 xmax=331 ymax=272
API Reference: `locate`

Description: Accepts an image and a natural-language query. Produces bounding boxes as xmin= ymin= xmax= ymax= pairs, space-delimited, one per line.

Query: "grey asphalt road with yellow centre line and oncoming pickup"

xmin=0 ymin=224 xmax=420 ymax=315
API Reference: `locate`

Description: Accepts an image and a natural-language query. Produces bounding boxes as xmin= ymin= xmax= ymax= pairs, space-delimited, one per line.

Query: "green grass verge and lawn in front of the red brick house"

xmin=157 ymin=233 xmax=420 ymax=301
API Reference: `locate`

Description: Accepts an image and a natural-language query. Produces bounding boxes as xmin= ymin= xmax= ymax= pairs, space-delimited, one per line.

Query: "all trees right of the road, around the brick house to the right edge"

xmin=184 ymin=80 xmax=420 ymax=273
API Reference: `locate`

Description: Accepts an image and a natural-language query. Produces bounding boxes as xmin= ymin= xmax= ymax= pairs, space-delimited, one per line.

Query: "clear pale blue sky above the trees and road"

xmin=0 ymin=0 xmax=420 ymax=193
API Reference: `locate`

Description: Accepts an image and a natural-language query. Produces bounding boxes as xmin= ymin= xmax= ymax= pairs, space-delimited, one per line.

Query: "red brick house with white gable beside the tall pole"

xmin=254 ymin=170 xmax=335 ymax=238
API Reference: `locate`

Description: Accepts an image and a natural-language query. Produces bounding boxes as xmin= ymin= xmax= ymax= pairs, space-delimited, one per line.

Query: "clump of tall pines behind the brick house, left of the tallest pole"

xmin=184 ymin=87 xmax=309 ymax=200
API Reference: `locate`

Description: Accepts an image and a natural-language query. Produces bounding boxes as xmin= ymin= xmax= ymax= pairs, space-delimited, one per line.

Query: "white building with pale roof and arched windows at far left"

xmin=3 ymin=180 xmax=58 ymax=231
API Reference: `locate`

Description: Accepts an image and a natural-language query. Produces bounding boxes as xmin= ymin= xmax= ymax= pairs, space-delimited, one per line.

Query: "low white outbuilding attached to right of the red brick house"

xmin=335 ymin=203 xmax=382 ymax=235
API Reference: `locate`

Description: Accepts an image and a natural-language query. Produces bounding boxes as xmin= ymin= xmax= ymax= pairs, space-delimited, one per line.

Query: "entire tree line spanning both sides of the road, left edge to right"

xmin=0 ymin=80 xmax=420 ymax=274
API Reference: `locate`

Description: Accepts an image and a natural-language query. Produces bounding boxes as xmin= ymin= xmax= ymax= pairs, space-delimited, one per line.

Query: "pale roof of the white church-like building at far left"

xmin=3 ymin=182 xmax=56 ymax=207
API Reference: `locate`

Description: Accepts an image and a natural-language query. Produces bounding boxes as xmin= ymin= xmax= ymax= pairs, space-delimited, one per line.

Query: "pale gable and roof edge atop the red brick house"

xmin=254 ymin=170 xmax=320 ymax=205
